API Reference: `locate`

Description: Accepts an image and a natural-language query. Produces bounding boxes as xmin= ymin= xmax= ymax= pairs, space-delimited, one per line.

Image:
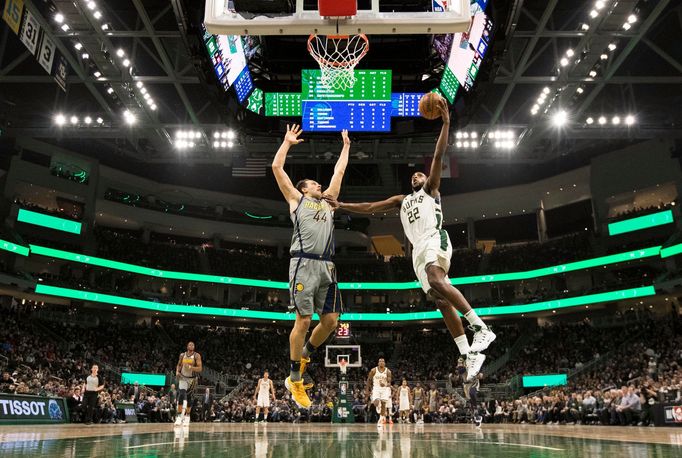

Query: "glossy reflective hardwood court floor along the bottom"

xmin=0 ymin=423 xmax=682 ymax=458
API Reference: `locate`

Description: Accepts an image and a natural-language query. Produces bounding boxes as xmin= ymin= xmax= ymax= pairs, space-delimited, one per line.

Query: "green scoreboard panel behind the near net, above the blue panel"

xmin=301 ymin=70 xmax=393 ymax=101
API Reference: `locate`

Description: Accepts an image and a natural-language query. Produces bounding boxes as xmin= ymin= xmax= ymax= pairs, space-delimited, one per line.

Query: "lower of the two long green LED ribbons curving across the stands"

xmin=31 ymin=284 xmax=656 ymax=322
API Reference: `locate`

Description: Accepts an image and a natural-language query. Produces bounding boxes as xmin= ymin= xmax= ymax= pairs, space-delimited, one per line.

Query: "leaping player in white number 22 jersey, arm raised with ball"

xmin=327 ymin=97 xmax=495 ymax=380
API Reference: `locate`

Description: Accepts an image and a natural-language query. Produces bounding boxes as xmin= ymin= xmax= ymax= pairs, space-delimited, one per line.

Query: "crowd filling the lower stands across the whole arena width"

xmin=0 ymin=301 xmax=682 ymax=425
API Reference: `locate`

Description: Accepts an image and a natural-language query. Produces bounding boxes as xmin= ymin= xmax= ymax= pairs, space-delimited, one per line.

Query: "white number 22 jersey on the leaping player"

xmin=400 ymin=188 xmax=443 ymax=245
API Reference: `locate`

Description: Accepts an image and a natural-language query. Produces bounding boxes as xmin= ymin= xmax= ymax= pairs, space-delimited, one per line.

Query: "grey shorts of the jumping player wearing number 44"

xmin=289 ymin=258 xmax=343 ymax=316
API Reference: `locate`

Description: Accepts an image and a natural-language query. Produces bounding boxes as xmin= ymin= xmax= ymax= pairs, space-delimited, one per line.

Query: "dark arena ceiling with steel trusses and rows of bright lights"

xmin=0 ymin=0 xmax=682 ymax=184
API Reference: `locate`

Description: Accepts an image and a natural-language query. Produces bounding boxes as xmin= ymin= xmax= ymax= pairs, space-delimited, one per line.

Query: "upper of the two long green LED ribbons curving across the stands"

xmin=29 ymin=245 xmax=660 ymax=290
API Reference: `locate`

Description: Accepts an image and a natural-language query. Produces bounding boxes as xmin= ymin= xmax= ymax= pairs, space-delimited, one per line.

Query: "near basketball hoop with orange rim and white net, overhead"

xmin=308 ymin=33 xmax=369 ymax=91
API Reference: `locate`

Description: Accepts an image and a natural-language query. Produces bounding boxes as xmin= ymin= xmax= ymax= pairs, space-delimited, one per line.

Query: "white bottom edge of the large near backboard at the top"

xmin=204 ymin=0 xmax=471 ymax=35
